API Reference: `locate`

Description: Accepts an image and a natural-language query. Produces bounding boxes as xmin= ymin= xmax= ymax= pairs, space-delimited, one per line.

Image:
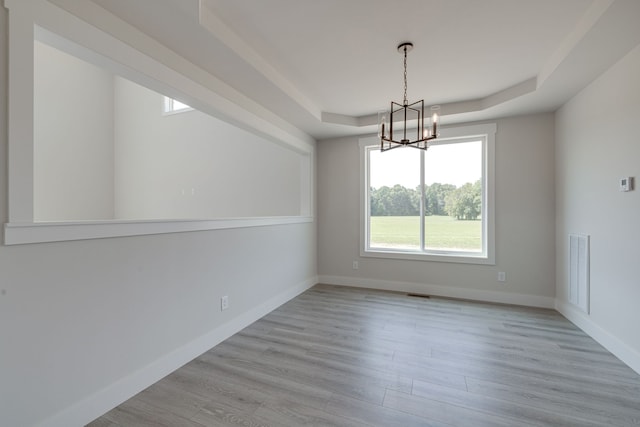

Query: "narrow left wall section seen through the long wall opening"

xmin=33 ymin=42 xmax=114 ymax=221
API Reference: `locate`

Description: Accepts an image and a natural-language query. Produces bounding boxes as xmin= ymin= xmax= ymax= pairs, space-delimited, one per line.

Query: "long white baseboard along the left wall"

xmin=40 ymin=276 xmax=318 ymax=427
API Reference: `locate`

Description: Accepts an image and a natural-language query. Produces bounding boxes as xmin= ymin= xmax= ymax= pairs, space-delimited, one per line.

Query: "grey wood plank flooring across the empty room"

xmin=89 ymin=285 xmax=640 ymax=427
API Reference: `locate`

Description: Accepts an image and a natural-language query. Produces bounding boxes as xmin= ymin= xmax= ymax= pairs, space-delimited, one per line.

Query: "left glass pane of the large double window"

xmin=369 ymin=148 xmax=420 ymax=250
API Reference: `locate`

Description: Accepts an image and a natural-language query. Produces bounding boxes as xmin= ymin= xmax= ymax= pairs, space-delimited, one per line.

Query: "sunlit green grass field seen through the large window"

xmin=371 ymin=216 xmax=482 ymax=251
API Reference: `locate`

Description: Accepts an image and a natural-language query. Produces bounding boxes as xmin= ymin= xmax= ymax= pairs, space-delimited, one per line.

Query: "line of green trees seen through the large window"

xmin=369 ymin=180 xmax=482 ymax=220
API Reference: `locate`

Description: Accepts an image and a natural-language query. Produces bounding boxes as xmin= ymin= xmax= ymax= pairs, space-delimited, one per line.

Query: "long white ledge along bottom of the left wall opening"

xmin=4 ymin=216 xmax=313 ymax=245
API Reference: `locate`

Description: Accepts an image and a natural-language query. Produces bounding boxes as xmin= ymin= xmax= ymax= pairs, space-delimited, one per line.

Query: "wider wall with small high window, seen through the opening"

xmin=115 ymin=77 xmax=306 ymax=219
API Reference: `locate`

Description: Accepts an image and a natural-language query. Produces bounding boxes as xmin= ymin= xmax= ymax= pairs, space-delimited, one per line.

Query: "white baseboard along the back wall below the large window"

xmin=318 ymin=275 xmax=555 ymax=308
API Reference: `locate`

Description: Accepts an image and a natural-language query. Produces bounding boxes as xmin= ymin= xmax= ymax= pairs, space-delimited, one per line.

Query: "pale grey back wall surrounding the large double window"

xmin=318 ymin=114 xmax=555 ymax=306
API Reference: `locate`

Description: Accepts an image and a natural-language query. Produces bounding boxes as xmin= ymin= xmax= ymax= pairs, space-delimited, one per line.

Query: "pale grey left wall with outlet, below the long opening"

xmin=0 ymin=7 xmax=316 ymax=427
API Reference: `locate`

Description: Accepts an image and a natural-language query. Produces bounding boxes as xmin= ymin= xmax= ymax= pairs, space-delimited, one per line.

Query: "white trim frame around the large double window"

xmin=359 ymin=123 xmax=497 ymax=265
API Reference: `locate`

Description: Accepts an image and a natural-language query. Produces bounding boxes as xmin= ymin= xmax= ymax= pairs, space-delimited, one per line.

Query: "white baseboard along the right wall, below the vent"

xmin=555 ymin=300 xmax=640 ymax=374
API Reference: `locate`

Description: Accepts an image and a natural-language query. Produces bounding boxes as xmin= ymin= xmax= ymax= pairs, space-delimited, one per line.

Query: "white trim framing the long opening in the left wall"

xmin=4 ymin=0 xmax=315 ymax=245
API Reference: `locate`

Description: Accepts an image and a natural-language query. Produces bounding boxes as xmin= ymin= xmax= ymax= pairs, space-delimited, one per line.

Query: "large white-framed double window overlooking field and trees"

xmin=361 ymin=125 xmax=495 ymax=264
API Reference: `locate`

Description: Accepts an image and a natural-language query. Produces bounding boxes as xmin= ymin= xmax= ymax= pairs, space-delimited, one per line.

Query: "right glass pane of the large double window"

xmin=424 ymin=141 xmax=482 ymax=252
